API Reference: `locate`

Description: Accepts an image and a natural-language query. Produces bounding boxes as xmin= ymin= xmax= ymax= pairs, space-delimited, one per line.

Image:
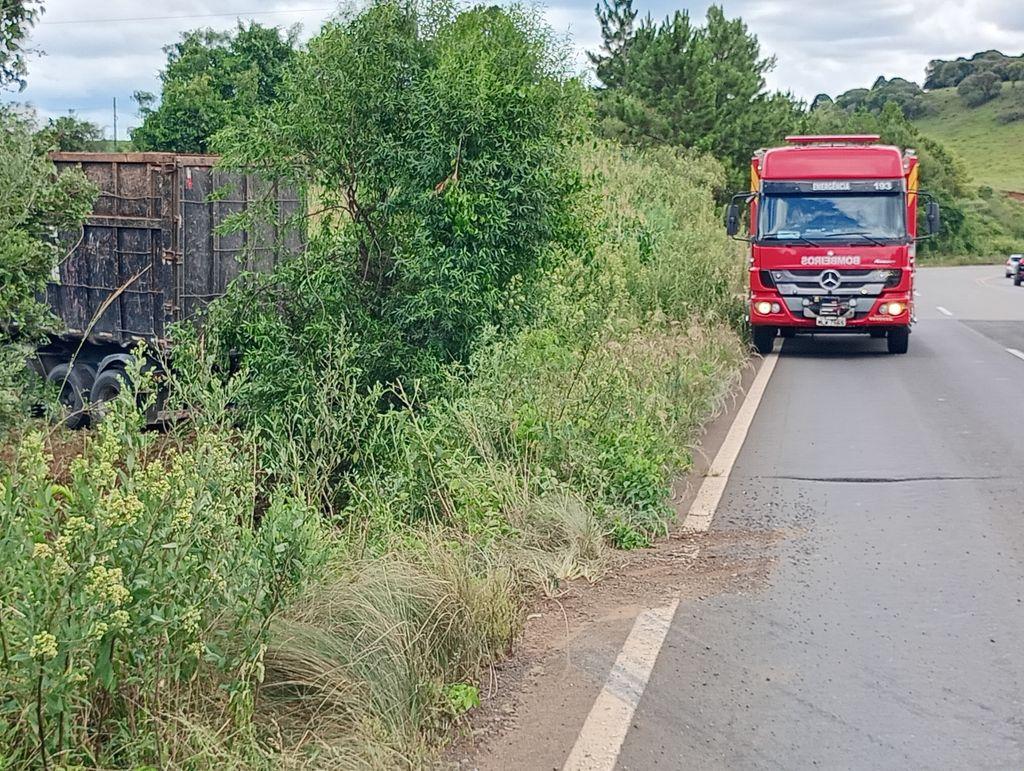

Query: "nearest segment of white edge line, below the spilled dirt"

xmin=563 ymin=600 xmax=679 ymax=771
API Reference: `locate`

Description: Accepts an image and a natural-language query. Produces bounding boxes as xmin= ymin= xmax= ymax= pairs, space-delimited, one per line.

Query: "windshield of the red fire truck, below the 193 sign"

xmin=758 ymin=192 xmax=906 ymax=242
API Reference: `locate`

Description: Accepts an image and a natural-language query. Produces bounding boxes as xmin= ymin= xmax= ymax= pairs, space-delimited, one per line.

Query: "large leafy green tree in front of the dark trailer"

xmin=211 ymin=0 xmax=587 ymax=382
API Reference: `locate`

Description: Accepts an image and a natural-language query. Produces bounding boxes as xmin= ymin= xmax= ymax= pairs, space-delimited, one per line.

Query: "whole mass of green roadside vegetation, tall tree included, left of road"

xmin=0 ymin=2 xmax=744 ymax=769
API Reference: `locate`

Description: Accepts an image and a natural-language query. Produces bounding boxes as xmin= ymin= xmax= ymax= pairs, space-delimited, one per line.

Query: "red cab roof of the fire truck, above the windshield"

xmin=758 ymin=134 xmax=906 ymax=179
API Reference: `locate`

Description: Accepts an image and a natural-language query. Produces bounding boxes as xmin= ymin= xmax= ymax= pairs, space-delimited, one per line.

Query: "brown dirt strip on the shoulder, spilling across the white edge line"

xmin=440 ymin=529 xmax=795 ymax=769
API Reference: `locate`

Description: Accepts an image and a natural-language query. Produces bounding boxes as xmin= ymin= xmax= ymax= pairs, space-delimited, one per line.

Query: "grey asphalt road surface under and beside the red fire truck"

xmin=617 ymin=267 xmax=1024 ymax=769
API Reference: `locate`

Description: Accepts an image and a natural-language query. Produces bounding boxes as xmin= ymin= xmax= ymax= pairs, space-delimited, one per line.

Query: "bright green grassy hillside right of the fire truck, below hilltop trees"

xmin=914 ymin=88 xmax=1024 ymax=192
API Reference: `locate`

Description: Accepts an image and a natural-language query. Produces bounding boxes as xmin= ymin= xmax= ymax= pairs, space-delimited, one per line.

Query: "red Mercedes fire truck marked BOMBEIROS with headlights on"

xmin=726 ymin=135 xmax=939 ymax=353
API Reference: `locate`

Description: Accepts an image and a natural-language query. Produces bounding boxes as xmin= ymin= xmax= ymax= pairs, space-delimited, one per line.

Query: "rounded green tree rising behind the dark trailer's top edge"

xmin=131 ymin=23 xmax=296 ymax=153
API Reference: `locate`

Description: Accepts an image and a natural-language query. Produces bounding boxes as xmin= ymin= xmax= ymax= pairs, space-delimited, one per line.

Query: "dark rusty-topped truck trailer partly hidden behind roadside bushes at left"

xmin=34 ymin=153 xmax=302 ymax=427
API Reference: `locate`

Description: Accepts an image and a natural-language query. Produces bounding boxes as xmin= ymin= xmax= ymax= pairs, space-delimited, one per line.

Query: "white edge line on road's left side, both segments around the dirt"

xmin=562 ymin=353 xmax=778 ymax=771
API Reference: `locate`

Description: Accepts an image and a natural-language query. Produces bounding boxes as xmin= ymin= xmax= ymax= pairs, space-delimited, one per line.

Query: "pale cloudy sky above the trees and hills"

xmin=8 ymin=0 xmax=1024 ymax=138
